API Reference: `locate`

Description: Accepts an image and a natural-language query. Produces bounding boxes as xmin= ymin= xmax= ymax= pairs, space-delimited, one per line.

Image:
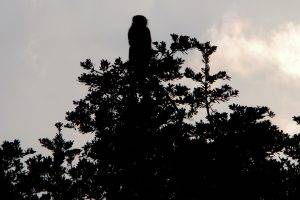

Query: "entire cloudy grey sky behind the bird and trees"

xmin=0 ymin=0 xmax=300 ymax=148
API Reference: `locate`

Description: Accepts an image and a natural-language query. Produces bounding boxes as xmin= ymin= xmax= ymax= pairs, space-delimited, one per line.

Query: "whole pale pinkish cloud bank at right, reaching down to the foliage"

xmin=202 ymin=15 xmax=300 ymax=133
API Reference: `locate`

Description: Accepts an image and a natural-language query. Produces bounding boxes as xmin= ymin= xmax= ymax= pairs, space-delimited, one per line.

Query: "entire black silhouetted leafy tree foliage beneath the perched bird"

xmin=0 ymin=34 xmax=300 ymax=200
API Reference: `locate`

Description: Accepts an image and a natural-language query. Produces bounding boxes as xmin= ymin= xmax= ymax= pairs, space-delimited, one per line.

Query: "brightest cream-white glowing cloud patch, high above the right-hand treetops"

xmin=209 ymin=18 xmax=300 ymax=77
